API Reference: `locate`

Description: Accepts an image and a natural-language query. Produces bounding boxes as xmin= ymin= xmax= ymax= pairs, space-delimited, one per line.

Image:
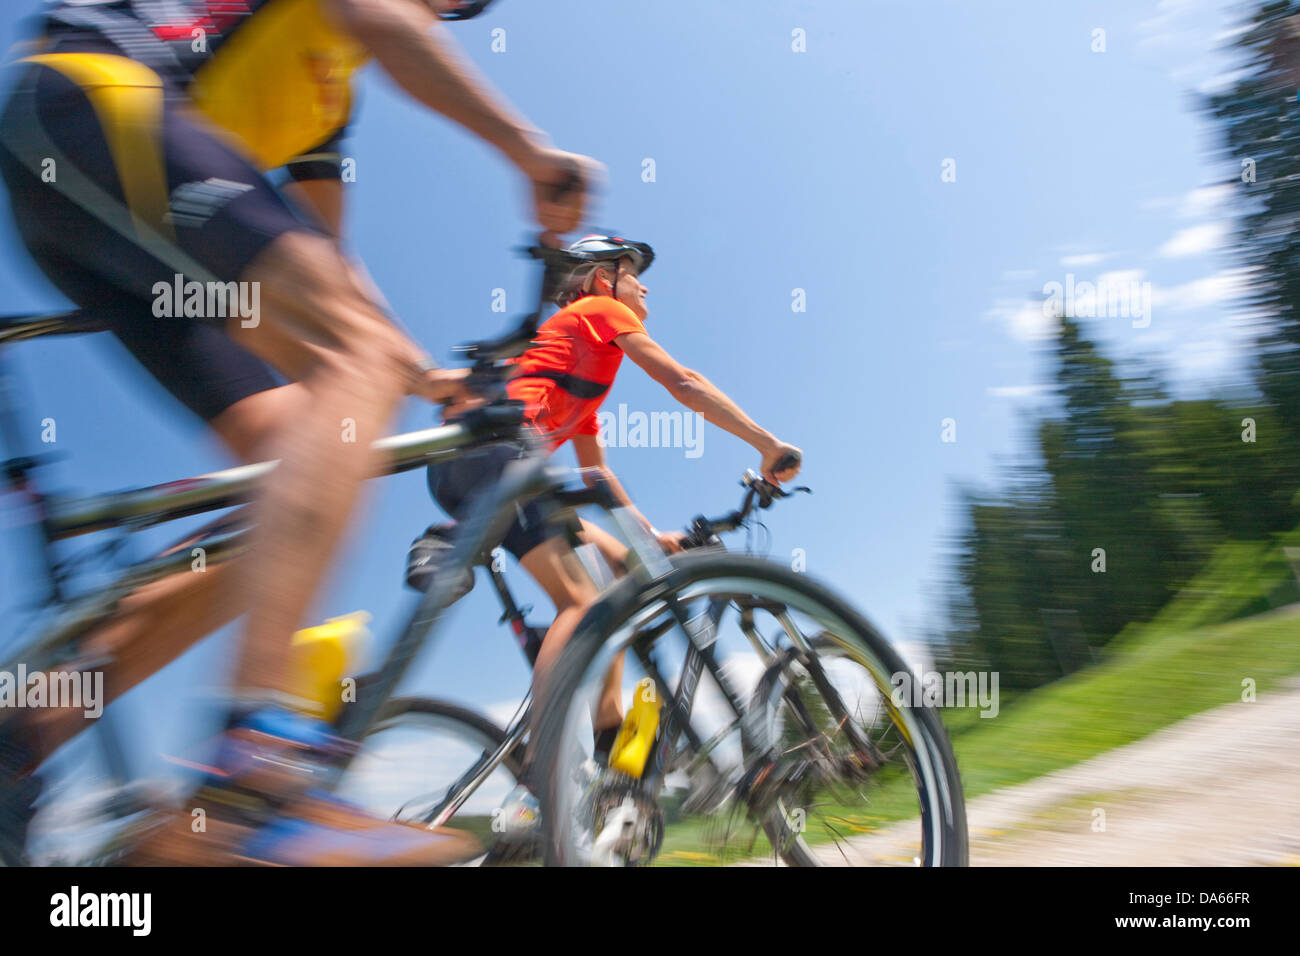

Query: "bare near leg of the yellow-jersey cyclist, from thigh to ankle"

xmin=220 ymin=233 xmax=421 ymax=695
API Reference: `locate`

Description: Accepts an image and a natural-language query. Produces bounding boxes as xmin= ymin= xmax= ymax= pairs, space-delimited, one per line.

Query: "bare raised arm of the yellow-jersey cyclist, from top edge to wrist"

xmin=326 ymin=0 xmax=545 ymax=174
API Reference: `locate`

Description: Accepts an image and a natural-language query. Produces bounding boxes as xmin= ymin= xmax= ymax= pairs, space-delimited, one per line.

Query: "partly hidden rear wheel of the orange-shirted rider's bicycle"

xmin=337 ymin=697 xmax=523 ymax=858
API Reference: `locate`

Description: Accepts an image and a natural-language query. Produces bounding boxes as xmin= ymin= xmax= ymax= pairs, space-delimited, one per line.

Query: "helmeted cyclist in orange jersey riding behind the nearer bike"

xmin=417 ymin=235 xmax=802 ymax=834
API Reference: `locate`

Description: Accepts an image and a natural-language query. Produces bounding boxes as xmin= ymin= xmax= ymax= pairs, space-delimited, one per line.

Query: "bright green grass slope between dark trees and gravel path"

xmin=837 ymin=529 xmax=1300 ymax=832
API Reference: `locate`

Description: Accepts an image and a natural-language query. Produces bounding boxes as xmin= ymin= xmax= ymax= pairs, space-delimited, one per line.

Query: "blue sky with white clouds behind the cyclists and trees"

xmin=0 ymin=0 xmax=1244 ymax=780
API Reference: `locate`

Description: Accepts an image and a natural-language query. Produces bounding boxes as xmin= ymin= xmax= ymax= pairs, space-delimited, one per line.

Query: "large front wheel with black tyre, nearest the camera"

xmin=537 ymin=554 xmax=967 ymax=866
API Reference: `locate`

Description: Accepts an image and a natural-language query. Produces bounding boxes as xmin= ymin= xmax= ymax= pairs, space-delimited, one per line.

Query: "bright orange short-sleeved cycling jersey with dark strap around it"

xmin=507 ymin=295 xmax=646 ymax=449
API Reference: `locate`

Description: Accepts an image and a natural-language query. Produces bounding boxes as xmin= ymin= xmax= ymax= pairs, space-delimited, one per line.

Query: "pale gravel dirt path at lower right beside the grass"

xmin=806 ymin=679 xmax=1300 ymax=866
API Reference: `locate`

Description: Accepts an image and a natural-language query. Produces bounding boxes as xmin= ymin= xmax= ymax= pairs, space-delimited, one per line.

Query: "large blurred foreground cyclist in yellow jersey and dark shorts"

xmin=0 ymin=0 xmax=598 ymax=864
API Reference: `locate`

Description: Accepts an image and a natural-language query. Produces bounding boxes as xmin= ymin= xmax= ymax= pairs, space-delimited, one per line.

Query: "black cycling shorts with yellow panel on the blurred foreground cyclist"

xmin=0 ymin=33 xmax=320 ymax=420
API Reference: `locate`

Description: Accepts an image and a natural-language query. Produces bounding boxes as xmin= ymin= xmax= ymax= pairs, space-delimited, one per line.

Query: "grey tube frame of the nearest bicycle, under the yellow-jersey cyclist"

xmin=0 ymin=325 xmax=702 ymax=816
